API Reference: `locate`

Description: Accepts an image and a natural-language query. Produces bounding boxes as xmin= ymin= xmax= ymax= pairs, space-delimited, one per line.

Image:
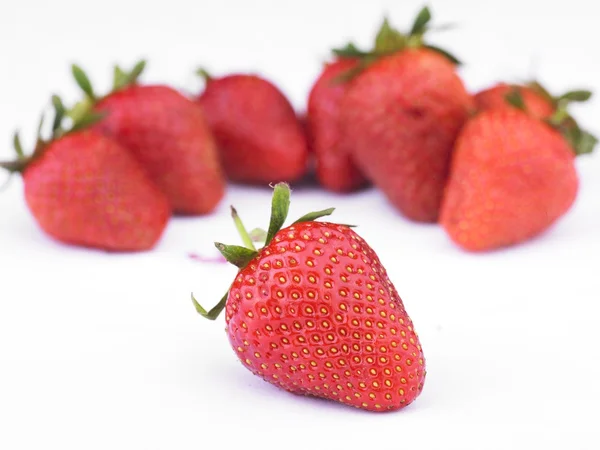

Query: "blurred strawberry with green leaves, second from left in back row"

xmin=68 ymin=62 xmax=225 ymax=215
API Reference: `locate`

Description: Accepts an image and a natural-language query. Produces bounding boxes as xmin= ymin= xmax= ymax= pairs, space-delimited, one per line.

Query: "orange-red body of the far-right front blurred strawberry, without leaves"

xmin=440 ymin=108 xmax=579 ymax=251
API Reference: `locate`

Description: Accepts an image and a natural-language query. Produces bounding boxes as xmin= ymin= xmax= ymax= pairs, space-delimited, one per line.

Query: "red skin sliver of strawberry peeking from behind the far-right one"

xmin=474 ymin=83 xmax=555 ymax=119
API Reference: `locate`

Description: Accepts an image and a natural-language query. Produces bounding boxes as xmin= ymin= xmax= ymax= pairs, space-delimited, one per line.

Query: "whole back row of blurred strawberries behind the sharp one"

xmin=0 ymin=8 xmax=596 ymax=251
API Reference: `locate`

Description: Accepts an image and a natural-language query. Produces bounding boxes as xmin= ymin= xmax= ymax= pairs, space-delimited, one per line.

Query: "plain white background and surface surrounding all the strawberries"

xmin=0 ymin=0 xmax=600 ymax=450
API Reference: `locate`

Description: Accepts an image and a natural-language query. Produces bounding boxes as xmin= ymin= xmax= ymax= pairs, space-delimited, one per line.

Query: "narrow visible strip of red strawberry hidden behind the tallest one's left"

xmin=307 ymin=58 xmax=366 ymax=192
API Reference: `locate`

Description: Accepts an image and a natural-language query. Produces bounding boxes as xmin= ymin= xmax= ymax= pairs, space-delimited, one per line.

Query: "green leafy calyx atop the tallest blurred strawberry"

xmin=332 ymin=7 xmax=460 ymax=81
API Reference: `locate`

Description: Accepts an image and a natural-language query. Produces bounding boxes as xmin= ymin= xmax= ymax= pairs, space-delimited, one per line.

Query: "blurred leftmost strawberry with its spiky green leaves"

xmin=0 ymin=97 xmax=170 ymax=251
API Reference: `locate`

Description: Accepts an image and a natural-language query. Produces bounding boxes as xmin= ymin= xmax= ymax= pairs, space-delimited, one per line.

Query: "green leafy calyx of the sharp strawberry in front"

xmin=192 ymin=183 xmax=335 ymax=320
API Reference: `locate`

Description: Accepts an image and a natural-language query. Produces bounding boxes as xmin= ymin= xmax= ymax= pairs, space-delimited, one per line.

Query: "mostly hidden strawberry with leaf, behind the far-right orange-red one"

xmin=474 ymin=81 xmax=591 ymax=119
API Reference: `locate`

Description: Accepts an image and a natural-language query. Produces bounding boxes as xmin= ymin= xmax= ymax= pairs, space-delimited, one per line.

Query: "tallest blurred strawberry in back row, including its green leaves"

xmin=336 ymin=8 xmax=473 ymax=222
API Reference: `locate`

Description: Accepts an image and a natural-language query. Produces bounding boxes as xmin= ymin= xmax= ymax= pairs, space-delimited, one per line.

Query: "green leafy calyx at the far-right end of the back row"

xmin=505 ymin=81 xmax=598 ymax=156
